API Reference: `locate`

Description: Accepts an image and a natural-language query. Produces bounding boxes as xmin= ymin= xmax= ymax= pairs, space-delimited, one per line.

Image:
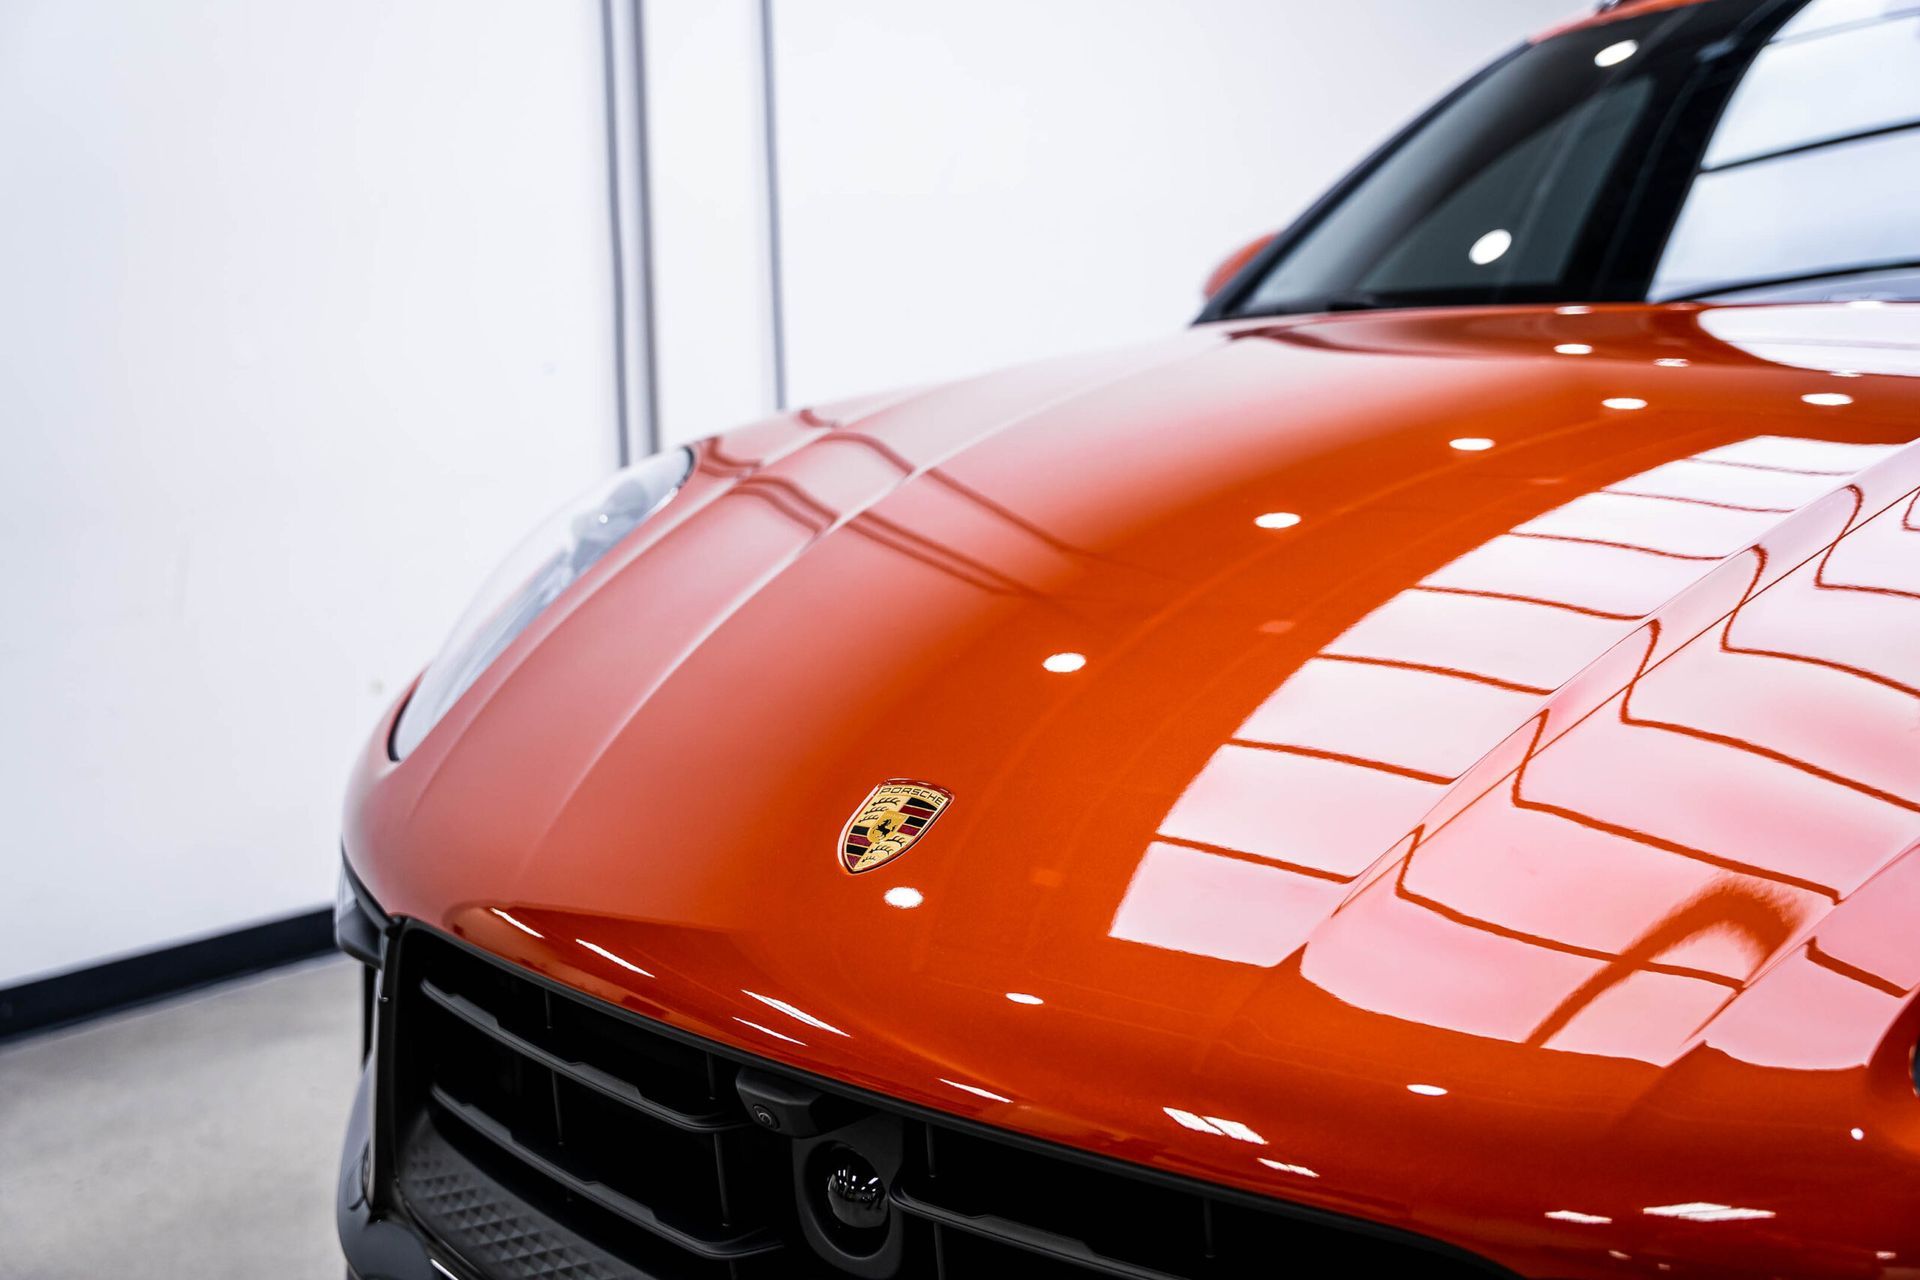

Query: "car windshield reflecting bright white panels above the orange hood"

xmin=1204 ymin=0 xmax=1920 ymax=319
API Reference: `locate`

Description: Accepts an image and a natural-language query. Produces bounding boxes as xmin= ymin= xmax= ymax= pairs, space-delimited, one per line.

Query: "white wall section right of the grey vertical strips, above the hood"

xmin=764 ymin=0 xmax=1584 ymax=403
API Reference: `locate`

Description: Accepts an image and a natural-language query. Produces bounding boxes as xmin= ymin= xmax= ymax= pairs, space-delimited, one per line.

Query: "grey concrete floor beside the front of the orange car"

xmin=0 ymin=958 xmax=359 ymax=1280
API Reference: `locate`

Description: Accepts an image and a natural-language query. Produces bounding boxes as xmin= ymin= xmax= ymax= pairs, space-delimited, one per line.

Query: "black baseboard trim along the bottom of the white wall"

xmin=0 ymin=908 xmax=334 ymax=1044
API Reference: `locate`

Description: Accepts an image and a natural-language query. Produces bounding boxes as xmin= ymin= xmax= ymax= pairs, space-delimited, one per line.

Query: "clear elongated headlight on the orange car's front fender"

xmin=394 ymin=449 xmax=693 ymax=760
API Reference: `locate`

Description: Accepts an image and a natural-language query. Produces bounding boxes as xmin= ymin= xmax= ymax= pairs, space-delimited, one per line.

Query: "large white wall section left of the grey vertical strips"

xmin=0 ymin=0 xmax=614 ymax=984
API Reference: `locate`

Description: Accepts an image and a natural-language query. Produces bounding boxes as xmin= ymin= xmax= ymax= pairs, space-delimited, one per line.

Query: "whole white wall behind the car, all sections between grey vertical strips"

xmin=0 ymin=0 xmax=1569 ymax=984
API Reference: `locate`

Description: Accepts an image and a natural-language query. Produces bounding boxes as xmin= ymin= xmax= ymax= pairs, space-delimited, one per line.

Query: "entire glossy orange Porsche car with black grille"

xmin=338 ymin=0 xmax=1920 ymax=1280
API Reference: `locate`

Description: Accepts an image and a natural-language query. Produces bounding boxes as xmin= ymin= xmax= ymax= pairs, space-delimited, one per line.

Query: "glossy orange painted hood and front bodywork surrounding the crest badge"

xmin=346 ymin=305 xmax=1920 ymax=1276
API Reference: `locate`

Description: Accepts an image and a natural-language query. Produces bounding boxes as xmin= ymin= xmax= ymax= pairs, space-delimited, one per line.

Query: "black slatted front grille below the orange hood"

xmin=380 ymin=927 xmax=1503 ymax=1280
